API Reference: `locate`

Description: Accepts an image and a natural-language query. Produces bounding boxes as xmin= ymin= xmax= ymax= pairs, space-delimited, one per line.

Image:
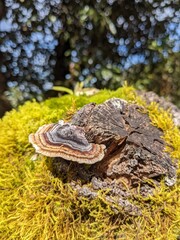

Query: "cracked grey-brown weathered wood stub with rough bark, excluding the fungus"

xmin=53 ymin=98 xmax=176 ymax=214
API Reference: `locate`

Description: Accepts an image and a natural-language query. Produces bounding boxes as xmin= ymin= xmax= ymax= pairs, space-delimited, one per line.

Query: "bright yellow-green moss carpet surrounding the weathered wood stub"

xmin=0 ymin=86 xmax=180 ymax=240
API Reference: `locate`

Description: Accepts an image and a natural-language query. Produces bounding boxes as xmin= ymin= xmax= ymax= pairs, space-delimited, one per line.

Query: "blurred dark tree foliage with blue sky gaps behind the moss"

xmin=0 ymin=0 xmax=180 ymax=115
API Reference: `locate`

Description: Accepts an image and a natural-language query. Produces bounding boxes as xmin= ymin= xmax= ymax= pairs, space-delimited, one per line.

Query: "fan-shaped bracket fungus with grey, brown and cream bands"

xmin=29 ymin=121 xmax=105 ymax=164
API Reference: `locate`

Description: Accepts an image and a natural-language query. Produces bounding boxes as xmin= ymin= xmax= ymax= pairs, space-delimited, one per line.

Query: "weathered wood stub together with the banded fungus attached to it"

xmin=29 ymin=98 xmax=176 ymax=212
